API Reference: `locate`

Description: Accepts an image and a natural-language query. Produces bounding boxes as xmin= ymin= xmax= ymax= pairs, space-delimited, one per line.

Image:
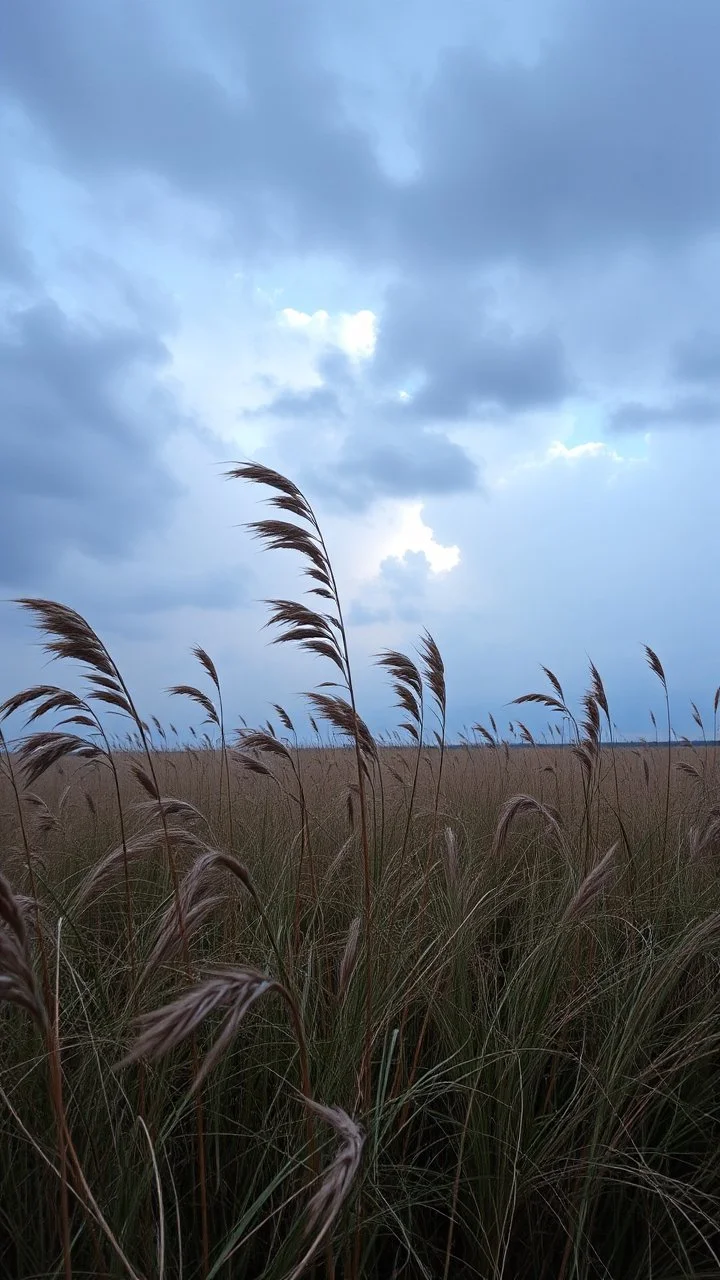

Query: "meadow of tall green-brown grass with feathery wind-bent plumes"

xmin=0 ymin=465 xmax=720 ymax=1280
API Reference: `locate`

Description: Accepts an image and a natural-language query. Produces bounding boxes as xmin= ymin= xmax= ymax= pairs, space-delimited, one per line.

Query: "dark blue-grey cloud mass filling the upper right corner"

xmin=397 ymin=0 xmax=720 ymax=270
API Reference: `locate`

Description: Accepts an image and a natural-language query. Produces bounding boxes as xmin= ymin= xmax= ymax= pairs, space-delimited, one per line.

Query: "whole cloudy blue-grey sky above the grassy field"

xmin=0 ymin=0 xmax=720 ymax=737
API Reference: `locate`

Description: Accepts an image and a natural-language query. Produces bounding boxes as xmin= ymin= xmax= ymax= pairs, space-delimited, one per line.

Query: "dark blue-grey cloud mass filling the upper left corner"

xmin=0 ymin=0 xmax=382 ymax=259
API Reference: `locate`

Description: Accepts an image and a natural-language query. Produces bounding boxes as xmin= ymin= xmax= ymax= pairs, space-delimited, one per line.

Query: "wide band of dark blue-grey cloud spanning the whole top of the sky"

xmin=0 ymin=0 xmax=720 ymax=270
